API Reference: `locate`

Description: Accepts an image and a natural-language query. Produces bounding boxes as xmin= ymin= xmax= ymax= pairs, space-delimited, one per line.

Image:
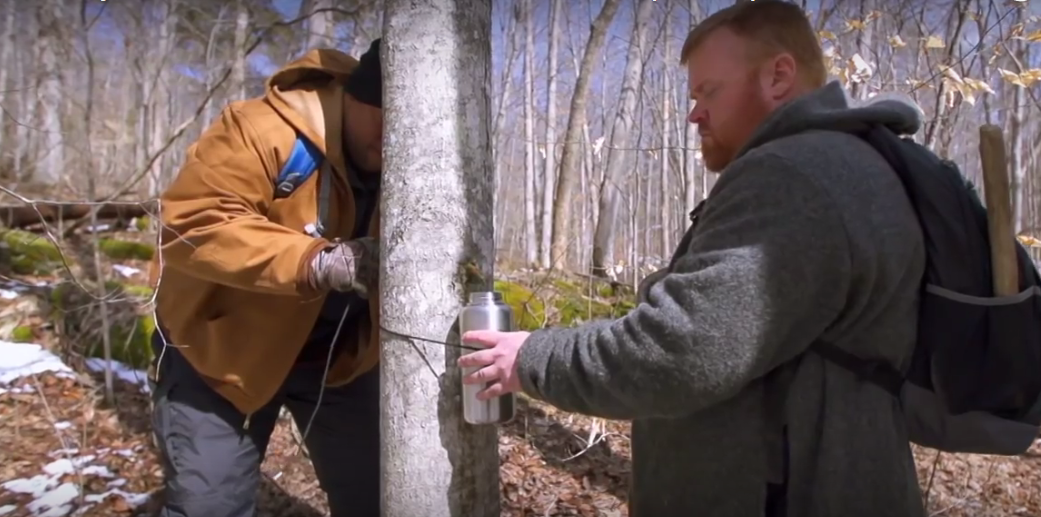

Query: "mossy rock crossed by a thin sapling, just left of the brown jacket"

xmin=48 ymin=282 xmax=155 ymax=369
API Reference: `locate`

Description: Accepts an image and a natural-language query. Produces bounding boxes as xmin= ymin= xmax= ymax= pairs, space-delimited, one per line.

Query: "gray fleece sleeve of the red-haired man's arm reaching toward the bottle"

xmin=517 ymin=149 xmax=849 ymax=419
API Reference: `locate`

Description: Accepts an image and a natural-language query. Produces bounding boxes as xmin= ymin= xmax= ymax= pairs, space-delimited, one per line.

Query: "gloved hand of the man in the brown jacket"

xmin=308 ymin=237 xmax=380 ymax=299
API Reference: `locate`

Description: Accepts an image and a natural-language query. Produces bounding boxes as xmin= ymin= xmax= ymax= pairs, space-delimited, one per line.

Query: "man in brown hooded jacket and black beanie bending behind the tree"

xmin=152 ymin=40 xmax=383 ymax=517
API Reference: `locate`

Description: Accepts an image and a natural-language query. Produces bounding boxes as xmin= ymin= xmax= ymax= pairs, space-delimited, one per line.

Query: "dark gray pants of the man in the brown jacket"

xmin=152 ymin=332 xmax=380 ymax=517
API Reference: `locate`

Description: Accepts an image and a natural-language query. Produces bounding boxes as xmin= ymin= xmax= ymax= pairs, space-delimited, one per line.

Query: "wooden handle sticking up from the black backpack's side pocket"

xmin=980 ymin=124 xmax=1019 ymax=296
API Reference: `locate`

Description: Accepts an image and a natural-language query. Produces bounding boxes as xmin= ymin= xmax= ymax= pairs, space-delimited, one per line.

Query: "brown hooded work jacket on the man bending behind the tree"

xmin=144 ymin=49 xmax=379 ymax=421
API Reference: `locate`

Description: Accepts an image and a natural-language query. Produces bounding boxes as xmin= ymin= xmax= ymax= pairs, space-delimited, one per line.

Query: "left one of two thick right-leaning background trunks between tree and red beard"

xmin=550 ymin=0 xmax=619 ymax=267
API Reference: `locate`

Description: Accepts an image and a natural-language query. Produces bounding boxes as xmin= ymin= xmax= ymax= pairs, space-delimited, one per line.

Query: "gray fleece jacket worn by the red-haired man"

xmin=518 ymin=82 xmax=924 ymax=517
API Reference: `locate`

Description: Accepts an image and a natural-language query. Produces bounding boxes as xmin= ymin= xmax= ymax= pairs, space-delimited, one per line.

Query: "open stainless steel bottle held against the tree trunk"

xmin=459 ymin=291 xmax=516 ymax=424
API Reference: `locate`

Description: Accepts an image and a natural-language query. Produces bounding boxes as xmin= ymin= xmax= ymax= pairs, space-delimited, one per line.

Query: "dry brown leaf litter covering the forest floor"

xmin=0 ymin=373 xmax=1041 ymax=517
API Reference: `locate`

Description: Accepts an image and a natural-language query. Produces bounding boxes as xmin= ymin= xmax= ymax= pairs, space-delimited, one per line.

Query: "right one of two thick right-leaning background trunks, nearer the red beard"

xmin=592 ymin=0 xmax=655 ymax=276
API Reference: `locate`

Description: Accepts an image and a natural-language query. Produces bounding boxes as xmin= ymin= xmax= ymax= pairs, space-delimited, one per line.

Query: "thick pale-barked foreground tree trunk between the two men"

xmin=380 ymin=0 xmax=500 ymax=517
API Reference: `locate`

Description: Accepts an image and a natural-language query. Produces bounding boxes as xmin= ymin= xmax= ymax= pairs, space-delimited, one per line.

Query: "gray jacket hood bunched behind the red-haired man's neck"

xmin=737 ymin=81 xmax=922 ymax=157
